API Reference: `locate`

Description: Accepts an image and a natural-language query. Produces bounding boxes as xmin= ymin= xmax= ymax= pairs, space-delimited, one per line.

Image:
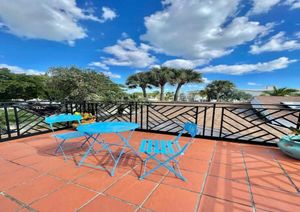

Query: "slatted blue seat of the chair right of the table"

xmin=139 ymin=139 xmax=181 ymax=155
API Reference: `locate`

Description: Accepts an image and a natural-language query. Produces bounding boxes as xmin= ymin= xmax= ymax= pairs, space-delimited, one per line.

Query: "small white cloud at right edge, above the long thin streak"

xmin=250 ymin=32 xmax=300 ymax=54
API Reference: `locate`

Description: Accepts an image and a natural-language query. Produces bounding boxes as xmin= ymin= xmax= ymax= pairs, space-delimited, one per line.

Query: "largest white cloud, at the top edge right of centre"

xmin=141 ymin=0 xmax=270 ymax=59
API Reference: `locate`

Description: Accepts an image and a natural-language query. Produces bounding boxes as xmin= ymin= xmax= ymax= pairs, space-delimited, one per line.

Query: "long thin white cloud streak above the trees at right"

xmin=198 ymin=57 xmax=297 ymax=75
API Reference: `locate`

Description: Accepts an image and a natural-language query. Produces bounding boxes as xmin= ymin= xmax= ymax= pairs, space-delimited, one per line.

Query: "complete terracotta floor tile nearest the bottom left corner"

xmin=7 ymin=175 xmax=64 ymax=204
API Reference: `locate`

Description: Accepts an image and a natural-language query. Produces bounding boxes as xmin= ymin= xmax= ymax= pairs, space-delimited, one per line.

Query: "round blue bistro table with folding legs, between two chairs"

xmin=77 ymin=122 xmax=141 ymax=176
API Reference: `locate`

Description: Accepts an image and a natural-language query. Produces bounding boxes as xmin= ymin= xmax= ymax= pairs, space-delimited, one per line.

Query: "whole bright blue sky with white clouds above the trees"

xmin=0 ymin=0 xmax=300 ymax=91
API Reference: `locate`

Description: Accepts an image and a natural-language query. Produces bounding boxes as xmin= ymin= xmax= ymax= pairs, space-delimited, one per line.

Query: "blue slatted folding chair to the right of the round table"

xmin=139 ymin=122 xmax=198 ymax=181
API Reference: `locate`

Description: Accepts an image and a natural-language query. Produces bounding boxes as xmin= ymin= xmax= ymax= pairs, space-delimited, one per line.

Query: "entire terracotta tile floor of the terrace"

xmin=0 ymin=132 xmax=300 ymax=212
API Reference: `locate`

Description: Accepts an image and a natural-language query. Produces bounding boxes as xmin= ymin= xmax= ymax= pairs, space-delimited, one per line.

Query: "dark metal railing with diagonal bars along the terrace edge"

xmin=0 ymin=102 xmax=300 ymax=145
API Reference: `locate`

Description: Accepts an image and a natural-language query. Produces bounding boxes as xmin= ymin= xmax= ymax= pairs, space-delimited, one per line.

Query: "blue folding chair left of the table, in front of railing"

xmin=45 ymin=114 xmax=90 ymax=160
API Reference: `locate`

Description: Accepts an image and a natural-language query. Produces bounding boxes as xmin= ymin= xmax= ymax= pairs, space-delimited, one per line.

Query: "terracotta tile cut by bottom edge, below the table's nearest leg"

xmin=80 ymin=195 xmax=135 ymax=212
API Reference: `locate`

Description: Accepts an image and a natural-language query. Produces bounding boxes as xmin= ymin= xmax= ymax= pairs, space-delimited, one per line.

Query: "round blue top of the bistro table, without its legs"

xmin=77 ymin=122 xmax=140 ymax=134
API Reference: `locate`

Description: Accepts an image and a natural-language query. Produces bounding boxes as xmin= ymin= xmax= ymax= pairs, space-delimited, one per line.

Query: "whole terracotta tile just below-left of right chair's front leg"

xmin=105 ymin=175 xmax=156 ymax=205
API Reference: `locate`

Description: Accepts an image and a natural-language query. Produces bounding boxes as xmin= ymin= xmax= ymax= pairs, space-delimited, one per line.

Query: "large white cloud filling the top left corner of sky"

xmin=0 ymin=0 xmax=112 ymax=45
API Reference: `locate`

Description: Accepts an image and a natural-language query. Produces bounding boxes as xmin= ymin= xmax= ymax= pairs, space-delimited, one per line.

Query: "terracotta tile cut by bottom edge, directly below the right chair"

xmin=143 ymin=184 xmax=198 ymax=211
